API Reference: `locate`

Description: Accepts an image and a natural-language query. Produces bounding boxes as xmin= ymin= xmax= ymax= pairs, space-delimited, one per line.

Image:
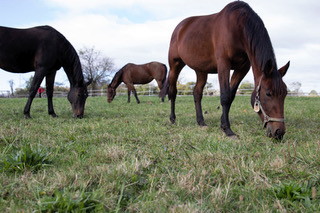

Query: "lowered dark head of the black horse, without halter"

xmin=68 ymin=79 xmax=92 ymax=118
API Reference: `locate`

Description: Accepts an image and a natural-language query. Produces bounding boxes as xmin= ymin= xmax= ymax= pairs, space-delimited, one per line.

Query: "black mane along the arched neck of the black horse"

xmin=56 ymin=27 xmax=84 ymax=86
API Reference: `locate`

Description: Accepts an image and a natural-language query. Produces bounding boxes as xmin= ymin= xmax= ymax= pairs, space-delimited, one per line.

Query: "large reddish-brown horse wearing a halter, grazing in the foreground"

xmin=161 ymin=1 xmax=289 ymax=139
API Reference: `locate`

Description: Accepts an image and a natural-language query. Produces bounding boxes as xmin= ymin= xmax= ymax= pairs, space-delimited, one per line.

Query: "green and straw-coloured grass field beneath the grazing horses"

xmin=0 ymin=96 xmax=320 ymax=213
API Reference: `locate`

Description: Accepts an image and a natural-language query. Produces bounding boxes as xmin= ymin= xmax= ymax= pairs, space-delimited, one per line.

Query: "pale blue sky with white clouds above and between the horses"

xmin=0 ymin=0 xmax=320 ymax=93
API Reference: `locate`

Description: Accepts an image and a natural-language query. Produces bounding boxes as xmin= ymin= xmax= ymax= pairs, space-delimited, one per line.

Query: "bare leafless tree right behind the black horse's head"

xmin=79 ymin=47 xmax=115 ymax=90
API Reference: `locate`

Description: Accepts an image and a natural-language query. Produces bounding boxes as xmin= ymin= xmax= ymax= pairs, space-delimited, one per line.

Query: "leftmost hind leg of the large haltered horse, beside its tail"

xmin=167 ymin=59 xmax=185 ymax=124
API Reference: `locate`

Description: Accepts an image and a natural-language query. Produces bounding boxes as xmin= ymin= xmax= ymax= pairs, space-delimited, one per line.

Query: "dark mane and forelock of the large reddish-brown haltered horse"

xmin=227 ymin=1 xmax=286 ymax=95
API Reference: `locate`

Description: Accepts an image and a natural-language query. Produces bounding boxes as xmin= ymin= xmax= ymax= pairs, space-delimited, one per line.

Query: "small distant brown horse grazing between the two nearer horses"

xmin=107 ymin=62 xmax=167 ymax=104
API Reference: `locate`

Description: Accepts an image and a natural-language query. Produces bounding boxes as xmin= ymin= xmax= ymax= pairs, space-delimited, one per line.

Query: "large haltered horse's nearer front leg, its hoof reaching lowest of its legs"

xmin=218 ymin=62 xmax=236 ymax=137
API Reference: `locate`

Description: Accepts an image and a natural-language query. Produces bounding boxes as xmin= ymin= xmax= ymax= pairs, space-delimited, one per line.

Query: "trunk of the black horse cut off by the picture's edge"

xmin=0 ymin=26 xmax=59 ymax=73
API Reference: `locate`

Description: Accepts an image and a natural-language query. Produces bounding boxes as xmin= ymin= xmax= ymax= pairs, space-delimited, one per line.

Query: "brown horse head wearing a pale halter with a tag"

xmin=251 ymin=62 xmax=290 ymax=140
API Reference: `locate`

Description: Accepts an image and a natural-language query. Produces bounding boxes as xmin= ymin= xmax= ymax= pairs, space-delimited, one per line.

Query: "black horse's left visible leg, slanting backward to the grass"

xmin=23 ymin=70 xmax=44 ymax=118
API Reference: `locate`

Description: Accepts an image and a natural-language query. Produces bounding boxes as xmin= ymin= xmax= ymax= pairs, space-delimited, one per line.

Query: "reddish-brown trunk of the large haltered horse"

xmin=169 ymin=4 xmax=248 ymax=73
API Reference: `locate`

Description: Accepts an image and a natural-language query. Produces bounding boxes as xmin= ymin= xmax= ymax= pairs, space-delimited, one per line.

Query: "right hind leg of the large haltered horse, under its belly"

xmin=193 ymin=72 xmax=208 ymax=126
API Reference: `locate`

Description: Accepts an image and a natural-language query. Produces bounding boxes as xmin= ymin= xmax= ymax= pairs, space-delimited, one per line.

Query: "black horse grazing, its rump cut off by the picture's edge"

xmin=0 ymin=26 xmax=90 ymax=118
